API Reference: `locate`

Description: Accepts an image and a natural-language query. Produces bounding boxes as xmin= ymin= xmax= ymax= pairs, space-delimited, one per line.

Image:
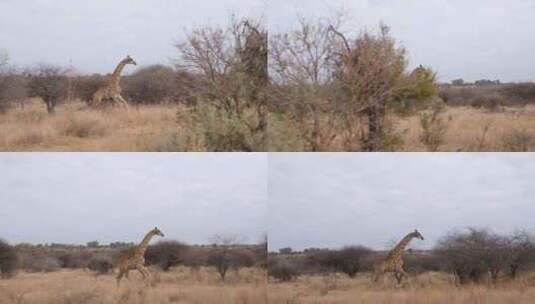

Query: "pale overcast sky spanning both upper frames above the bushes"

xmin=0 ymin=0 xmax=535 ymax=81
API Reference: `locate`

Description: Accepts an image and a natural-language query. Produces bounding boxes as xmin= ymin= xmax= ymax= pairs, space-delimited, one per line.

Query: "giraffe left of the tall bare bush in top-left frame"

xmin=91 ymin=55 xmax=137 ymax=108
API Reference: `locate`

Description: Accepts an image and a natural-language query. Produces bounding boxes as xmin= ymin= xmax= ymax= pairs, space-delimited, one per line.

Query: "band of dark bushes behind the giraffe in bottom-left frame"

xmin=0 ymin=241 xmax=267 ymax=279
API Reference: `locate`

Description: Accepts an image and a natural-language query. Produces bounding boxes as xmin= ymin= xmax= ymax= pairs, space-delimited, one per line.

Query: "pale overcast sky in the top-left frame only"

xmin=0 ymin=0 xmax=265 ymax=73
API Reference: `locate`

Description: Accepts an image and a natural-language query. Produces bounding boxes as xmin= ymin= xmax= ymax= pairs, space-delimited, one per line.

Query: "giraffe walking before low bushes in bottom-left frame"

xmin=117 ymin=227 xmax=164 ymax=285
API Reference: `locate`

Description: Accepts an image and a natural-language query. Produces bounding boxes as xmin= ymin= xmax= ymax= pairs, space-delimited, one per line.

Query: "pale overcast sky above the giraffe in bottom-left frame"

xmin=0 ymin=153 xmax=267 ymax=243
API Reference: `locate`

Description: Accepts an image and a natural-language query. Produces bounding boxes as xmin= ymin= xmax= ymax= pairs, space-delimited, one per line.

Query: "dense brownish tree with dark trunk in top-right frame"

xmin=330 ymin=24 xmax=407 ymax=151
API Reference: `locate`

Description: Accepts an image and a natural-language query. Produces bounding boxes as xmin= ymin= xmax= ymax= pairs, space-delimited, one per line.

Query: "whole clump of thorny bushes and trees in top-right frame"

xmin=269 ymin=17 xmax=435 ymax=151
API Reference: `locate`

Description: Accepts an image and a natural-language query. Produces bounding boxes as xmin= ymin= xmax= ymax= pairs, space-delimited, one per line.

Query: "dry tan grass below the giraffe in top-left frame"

xmin=0 ymin=101 xmax=178 ymax=151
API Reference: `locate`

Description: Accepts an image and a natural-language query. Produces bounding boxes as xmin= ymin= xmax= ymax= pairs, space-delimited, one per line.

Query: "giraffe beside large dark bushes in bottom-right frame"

xmin=374 ymin=230 xmax=424 ymax=284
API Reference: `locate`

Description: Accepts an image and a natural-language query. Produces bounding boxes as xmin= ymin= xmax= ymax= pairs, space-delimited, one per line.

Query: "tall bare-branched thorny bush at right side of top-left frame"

xmin=176 ymin=19 xmax=268 ymax=150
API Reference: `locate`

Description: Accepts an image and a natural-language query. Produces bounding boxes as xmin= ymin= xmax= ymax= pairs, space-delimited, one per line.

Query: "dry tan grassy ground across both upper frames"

xmin=0 ymin=100 xmax=535 ymax=151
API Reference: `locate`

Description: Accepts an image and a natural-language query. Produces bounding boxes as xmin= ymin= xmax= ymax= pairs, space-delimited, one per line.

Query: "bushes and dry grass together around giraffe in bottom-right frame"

xmin=268 ymin=228 xmax=535 ymax=304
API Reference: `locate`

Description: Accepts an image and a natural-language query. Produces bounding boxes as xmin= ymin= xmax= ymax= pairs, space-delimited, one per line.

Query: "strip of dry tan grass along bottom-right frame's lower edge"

xmin=268 ymin=273 xmax=535 ymax=304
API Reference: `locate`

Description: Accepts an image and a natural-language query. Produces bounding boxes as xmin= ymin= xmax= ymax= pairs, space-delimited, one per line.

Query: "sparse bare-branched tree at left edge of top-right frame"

xmin=269 ymin=18 xmax=339 ymax=151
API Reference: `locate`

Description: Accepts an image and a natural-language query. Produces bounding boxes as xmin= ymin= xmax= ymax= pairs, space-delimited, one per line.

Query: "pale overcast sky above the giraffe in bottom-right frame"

xmin=268 ymin=153 xmax=535 ymax=250
